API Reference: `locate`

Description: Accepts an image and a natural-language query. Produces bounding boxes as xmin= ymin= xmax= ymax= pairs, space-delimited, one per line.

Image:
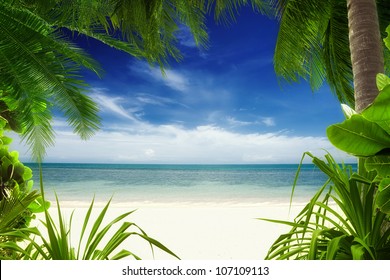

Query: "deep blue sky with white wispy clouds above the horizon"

xmin=13 ymin=10 xmax=350 ymax=163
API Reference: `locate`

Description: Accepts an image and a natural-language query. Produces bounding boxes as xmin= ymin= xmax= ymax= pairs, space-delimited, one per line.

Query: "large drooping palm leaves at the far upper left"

xmin=0 ymin=2 xmax=99 ymax=160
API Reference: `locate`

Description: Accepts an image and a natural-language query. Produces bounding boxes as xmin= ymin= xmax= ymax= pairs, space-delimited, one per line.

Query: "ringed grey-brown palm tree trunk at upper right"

xmin=347 ymin=0 xmax=384 ymax=112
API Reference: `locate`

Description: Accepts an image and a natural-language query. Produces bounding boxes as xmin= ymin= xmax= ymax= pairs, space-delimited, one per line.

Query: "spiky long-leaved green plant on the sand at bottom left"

xmin=5 ymin=198 xmax=178 ymax=260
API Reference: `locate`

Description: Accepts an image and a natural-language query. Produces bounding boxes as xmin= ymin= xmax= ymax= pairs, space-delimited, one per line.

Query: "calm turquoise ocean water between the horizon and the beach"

xmin=27 ymin=163 xmax=344 ymax=206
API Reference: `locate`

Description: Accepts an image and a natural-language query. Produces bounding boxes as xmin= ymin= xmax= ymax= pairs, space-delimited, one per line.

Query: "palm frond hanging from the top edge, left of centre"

xmin=110 ymin=0 xmax=190 ymax=66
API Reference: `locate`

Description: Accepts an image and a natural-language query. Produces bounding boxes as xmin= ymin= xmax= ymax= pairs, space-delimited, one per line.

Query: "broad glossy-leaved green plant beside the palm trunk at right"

xmin=327 ymin=74 xmax=390 ymax=214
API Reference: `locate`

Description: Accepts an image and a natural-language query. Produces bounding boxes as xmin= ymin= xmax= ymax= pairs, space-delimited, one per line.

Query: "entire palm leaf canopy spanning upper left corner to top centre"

xmin=0 ymin=0 xmax=269 ymax=161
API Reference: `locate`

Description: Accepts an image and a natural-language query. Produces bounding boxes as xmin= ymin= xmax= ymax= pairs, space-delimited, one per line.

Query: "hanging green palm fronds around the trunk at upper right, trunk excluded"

xmin=272 ymin=0 xmax=390 ymax=107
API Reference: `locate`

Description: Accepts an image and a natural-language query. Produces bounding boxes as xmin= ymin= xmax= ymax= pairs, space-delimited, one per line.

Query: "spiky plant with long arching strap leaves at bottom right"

xmin=261 ymin=153 xmax=390 ymax=260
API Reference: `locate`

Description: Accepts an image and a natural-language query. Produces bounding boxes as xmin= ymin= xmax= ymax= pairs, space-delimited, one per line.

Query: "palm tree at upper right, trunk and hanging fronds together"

xmin=273 ymin=0 xmax=390 ymax=111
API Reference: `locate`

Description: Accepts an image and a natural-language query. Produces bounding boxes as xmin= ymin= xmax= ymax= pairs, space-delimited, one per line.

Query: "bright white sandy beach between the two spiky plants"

xmin=34 ymin=203 xmax=303 ymax=260
